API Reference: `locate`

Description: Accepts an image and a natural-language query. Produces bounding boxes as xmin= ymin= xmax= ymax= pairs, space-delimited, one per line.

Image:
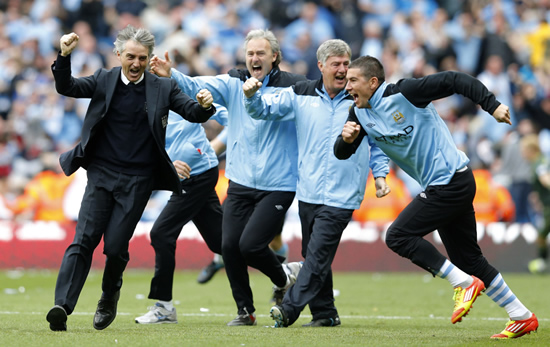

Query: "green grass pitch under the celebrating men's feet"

xmin=0 ymin=269 xmax=550 ymax=347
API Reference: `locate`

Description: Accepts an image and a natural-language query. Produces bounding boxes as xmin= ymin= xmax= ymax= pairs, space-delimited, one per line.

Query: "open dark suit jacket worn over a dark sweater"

xmin=52 ymin=56 xmax=216 ymax=194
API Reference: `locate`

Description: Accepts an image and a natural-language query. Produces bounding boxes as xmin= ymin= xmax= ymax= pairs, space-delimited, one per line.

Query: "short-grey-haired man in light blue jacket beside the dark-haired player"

xmin=243 ymin=40 xmax=390 ymax=327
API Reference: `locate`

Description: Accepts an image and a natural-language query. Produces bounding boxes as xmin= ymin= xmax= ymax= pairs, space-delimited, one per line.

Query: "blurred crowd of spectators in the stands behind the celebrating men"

xmin=0 ymin=0 xmax=550 ymax=231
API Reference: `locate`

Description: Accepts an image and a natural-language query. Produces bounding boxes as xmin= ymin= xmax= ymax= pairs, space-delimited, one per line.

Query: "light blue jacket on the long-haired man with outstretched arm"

xmin=172 ymin=68 xmax=305 ymax=192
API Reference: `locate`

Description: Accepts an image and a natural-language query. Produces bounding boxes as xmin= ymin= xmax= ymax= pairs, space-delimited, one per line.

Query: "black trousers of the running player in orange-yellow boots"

xmin=386 ymin=169 xmax=498 ymax=286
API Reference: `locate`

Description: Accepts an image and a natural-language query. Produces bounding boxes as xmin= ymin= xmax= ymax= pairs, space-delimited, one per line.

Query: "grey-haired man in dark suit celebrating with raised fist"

xmin=46 ymin=26 xmax=216 ymax=331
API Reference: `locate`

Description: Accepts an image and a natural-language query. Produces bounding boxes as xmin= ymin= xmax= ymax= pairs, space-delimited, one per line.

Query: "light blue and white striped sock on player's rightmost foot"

xmin=485 ymin=273 xmax=532 ymax=321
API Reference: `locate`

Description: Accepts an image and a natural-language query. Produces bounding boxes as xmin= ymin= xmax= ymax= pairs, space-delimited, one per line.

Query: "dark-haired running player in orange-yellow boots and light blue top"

xmin=334 ymin=56 xmax=538 ymax=339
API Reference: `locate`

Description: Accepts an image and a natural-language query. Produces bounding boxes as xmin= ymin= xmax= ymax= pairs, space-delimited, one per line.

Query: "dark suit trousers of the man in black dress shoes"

xmin=55 ymin=165 xmax=153 ymax=314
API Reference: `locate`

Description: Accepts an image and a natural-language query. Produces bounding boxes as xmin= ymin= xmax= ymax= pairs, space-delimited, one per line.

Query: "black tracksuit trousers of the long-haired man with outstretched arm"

xmin=222 ymin=181 xmax=295 ymax=314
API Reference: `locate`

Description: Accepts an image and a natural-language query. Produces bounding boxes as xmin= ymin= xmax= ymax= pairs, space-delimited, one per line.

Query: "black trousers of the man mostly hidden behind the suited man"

xmin=149 ymin=166 xmax=222 ymax=301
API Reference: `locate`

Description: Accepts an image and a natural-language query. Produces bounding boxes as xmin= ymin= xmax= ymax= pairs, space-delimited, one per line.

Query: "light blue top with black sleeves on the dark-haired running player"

xmin=336 ymin=71 xmax=507 ymax=189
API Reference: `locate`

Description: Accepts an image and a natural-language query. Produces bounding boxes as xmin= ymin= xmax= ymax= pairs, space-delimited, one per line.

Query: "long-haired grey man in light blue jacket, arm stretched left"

xmin=151 ymin=30 xmax=305 ymax=326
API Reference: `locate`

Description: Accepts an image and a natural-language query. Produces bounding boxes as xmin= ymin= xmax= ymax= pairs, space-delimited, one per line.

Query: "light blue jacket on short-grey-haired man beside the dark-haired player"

xmin=243 ymin=80 xmax=389 ymax=209
